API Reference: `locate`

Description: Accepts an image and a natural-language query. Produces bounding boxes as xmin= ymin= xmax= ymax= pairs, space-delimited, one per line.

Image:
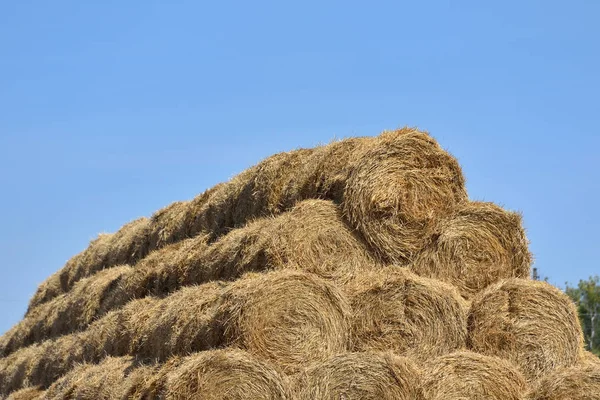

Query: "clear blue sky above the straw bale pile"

xmin=0 ymin=0 xmax=600 ymax=332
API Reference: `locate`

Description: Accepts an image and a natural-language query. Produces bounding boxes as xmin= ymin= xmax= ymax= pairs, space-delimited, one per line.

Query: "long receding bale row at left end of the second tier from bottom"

xmin=0 ymin=271 xmax=350 ymax=394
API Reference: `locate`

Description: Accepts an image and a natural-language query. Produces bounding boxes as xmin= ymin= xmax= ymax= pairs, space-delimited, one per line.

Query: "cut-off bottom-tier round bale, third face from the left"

xmin=423 ymin=351 xmax=527 ymax=400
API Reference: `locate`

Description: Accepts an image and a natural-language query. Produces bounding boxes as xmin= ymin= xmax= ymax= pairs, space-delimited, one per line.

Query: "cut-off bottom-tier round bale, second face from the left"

xmin=294 ymin=352 xmax=425 ymax=400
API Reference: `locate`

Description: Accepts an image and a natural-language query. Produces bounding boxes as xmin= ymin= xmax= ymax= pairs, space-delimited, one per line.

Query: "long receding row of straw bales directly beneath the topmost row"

xmin=8 ymin=200 xmax=375 ymax=355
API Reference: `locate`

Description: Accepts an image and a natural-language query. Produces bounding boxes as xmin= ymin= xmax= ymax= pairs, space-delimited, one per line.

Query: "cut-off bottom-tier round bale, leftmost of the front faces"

xmin=164 ymin=349 xmax=291 ymax=400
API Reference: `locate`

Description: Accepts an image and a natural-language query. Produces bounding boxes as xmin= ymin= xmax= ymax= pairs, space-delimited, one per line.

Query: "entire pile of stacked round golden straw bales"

xmin=0 ymin=128 xmax=600 ymax=400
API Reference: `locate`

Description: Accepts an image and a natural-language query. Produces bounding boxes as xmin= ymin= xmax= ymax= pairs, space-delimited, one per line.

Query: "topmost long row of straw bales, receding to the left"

xmin=30 ymin=128 xmax=467 ymax=309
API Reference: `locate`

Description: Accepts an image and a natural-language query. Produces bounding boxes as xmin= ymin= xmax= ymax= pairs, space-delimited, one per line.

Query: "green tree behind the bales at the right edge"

xmin=566 ymin=275 xmax=600 ymax=355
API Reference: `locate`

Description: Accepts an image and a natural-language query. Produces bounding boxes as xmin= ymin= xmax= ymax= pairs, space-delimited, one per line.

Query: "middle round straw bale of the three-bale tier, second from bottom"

xmin=346 ymin=267 xmax=468 ymax=360
